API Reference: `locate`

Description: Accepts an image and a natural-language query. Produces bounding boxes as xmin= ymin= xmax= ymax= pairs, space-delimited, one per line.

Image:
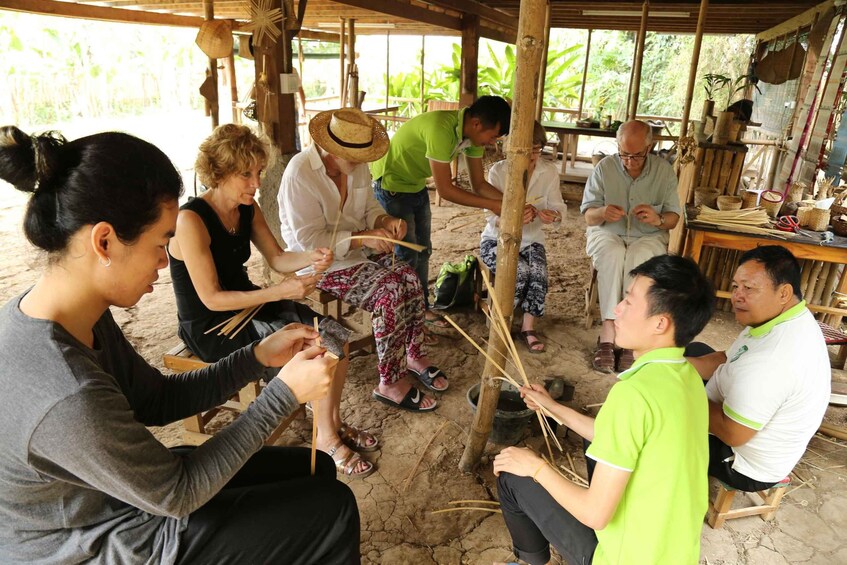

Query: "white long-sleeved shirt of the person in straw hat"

xmin=277 ymin=143 xmax=385 ymax=274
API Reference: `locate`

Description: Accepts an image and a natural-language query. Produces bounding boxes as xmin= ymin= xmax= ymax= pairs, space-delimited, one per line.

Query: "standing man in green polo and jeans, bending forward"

xmin=371 ymin=96 xmax=511 ymax=324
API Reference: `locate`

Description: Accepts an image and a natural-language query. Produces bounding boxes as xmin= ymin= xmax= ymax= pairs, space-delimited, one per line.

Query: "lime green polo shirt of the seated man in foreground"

xmin=586 ymin=347 xmax=709 ymax=564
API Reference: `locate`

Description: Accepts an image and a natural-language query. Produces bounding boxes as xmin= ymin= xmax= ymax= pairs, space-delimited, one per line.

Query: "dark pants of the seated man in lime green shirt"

xmin=497 ymin=473 xmax=597 ymax=565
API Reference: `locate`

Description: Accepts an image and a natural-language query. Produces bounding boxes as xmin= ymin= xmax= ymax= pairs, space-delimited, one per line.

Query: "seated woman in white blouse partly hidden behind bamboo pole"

xmin=479 ymin=122 xmax=567 ymax=353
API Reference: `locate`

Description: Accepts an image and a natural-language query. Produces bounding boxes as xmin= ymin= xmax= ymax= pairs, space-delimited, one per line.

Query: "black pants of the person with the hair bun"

xmin=175 ymin=447 xmax=360 ymax=565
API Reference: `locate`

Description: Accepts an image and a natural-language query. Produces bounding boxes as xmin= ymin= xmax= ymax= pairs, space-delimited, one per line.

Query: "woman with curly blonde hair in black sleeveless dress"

xmin=168 ymin=124 xmax=378 ymax=477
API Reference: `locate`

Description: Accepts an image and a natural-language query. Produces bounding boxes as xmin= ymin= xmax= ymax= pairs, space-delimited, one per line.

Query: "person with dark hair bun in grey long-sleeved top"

xmin=0 ymin=126 xmax=359 ymax=564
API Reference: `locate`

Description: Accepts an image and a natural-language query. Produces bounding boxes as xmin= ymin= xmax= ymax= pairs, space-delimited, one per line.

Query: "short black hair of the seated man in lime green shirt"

xmin=629 ymin=255 xmax=716 ymax=347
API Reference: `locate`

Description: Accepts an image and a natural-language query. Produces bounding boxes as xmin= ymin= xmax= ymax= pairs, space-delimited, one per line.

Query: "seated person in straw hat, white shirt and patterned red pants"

xmin=277 ymin=108 xmax=448 ymax=412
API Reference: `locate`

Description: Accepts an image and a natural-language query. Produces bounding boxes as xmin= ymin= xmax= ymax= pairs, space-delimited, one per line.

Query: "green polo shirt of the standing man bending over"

xmin=371 ymin=108 xmax=484 ymax=193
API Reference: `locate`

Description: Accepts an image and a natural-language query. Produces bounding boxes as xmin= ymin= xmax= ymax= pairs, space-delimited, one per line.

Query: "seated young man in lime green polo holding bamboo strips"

xmin=494 ymin=255 xmax=715 ymax=565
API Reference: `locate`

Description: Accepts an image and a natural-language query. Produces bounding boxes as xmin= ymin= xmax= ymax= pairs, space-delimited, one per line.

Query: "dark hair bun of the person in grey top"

xmin=0 ymin=126 xmax=65 ymax=192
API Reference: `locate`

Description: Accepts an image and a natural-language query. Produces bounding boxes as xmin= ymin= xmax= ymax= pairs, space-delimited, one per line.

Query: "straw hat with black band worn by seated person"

xmin=309 ymin=108 xmax=388 ymax=163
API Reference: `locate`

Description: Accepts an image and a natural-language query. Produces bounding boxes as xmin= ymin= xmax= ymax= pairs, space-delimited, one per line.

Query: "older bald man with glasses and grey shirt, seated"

xmin=580 ymin=120 xmax=681 ymax=373
